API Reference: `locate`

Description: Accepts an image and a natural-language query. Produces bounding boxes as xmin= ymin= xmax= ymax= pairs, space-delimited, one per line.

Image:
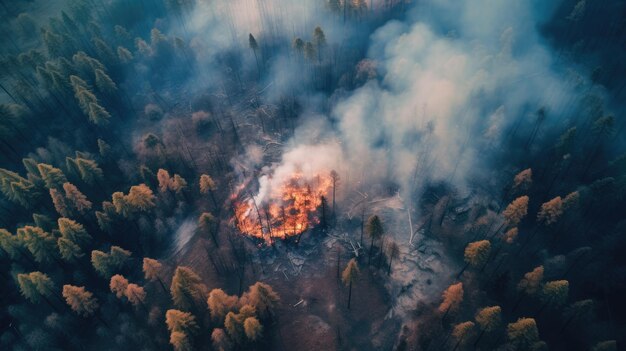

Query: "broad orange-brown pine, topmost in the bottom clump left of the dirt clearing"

xmin=170 ymin=266 xmax=206 ymax=309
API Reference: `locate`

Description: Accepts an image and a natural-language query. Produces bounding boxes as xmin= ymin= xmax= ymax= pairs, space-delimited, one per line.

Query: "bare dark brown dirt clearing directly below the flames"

xmin=176 ymin=217 xmax=400 ymax=350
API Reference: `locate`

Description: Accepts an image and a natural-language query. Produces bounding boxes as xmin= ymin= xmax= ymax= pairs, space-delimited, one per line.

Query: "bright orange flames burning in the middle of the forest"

xmin=233 ymin=171 xmax=332 ymax=243
